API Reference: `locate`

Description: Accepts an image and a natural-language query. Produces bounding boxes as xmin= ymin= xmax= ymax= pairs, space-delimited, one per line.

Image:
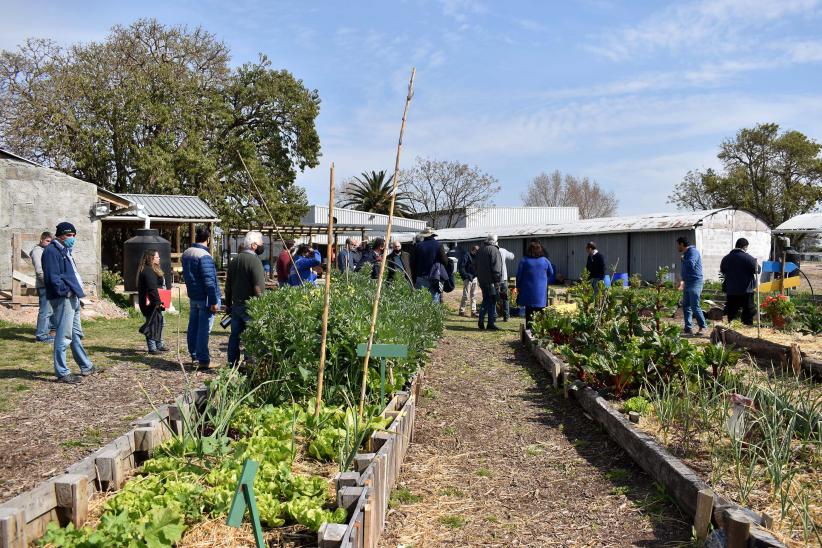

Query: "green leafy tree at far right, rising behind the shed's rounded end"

xmin=669 ymin=124 xmax=822 ymax=226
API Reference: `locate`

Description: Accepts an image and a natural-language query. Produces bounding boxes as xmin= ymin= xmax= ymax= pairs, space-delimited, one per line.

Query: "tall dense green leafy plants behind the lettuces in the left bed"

xmin=243 ymin=275 xmax=443 ymax=404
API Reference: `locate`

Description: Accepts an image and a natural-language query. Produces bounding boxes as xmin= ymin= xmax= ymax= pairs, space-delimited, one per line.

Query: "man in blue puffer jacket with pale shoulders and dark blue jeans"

xmin=182 ymin=227 xmax=220 ymax=369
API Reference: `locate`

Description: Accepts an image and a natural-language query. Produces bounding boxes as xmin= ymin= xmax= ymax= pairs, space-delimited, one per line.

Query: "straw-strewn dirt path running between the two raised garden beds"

xmin=381 ymin=304 xmax=690 ymax=548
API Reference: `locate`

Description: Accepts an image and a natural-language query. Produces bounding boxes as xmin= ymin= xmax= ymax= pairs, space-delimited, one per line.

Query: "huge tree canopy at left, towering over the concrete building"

xmin=0 ymin=19 xmax=320 ymax=226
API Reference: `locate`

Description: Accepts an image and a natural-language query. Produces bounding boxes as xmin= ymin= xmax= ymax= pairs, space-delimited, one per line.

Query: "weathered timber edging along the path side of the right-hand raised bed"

xmin=522 ymin=329 xmax=785 ymax=548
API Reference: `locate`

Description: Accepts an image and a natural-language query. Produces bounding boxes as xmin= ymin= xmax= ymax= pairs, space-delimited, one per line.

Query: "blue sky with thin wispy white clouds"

xmin=0 ymin=0 xmax=822 ymax=214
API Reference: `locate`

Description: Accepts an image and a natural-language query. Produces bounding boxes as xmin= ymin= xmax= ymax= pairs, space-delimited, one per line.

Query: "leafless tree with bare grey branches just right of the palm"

xmin=400 ymin=157 xmax=500 ymax=228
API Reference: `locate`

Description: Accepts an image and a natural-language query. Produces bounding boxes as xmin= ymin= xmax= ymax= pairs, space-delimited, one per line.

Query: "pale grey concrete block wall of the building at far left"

xmin=0 ymin=158 xmax=101 ymax=294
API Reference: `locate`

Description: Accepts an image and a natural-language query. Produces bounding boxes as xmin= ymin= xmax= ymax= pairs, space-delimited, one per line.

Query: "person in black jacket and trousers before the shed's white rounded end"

xmin=719 ymin=238 xmax=757 ymax=325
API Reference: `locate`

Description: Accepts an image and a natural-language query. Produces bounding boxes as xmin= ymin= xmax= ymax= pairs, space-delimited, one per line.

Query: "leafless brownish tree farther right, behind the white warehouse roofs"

xmin=522 ymin=170 xmax=619 ymax=219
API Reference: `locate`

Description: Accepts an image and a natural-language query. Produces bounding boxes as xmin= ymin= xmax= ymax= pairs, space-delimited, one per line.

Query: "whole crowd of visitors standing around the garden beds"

xmin=30 ymin=222 xmax=772 ymax=384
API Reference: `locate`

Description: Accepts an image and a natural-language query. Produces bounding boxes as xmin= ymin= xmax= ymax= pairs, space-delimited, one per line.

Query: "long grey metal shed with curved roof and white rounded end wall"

xmin=403 ymin=208 xmax=771 ymax=280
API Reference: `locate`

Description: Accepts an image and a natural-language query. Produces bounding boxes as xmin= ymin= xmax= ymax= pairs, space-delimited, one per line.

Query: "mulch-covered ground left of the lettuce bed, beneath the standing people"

xmin=0 ymin=328 xmax=226 ymax=501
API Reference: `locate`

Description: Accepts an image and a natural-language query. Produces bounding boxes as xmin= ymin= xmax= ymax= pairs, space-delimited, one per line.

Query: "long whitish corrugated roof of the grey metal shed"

xmin=397 ymin=208 xmax=726 ymax=241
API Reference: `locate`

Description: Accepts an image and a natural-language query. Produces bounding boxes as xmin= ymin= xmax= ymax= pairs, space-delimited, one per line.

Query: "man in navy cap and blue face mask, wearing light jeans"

xmin=42 ymin=222 xmax=95 ymax=384
